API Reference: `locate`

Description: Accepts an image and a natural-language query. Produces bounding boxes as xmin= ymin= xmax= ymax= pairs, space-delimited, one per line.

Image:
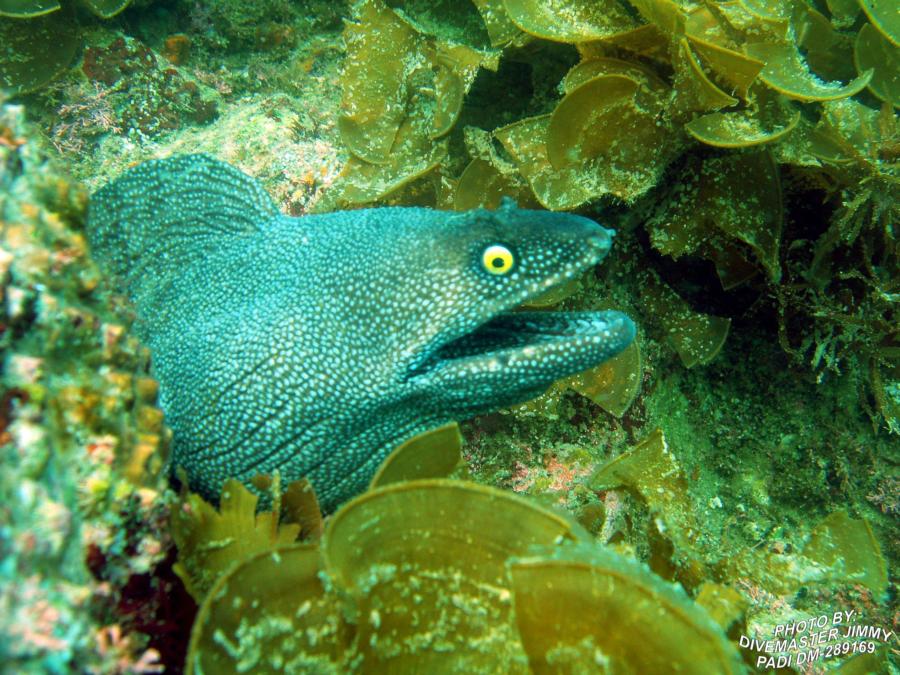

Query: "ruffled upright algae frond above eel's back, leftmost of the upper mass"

xmin=330 ymin=0 xmax=496 ymax=204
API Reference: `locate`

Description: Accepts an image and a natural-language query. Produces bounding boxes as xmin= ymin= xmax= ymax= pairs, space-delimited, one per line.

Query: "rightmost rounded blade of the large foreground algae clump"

xmin=510 ymin=546 xmax=744 ymax=673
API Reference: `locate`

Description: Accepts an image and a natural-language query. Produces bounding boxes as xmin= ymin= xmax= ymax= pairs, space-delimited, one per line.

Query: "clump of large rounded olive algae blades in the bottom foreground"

xmin=181 ymin=479 xmax=742 ymax=673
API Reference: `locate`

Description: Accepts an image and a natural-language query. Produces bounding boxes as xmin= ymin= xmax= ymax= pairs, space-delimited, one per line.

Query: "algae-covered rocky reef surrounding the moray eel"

xmin=0 ymin=0 xmax=900 ymax=673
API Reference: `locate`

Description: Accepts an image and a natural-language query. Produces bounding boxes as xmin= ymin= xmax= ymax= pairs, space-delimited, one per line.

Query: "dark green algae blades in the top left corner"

xmin=0 ymin=0 xmax=131 ymax=94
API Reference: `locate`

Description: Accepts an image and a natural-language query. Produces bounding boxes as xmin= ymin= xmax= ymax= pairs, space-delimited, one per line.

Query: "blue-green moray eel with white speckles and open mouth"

xmin=88 ymin=155 xmax=635 ymax=511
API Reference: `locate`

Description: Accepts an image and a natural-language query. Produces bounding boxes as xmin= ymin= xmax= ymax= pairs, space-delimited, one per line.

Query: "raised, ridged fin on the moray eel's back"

xmin=88 ymin=155 xmax=279 ymax=296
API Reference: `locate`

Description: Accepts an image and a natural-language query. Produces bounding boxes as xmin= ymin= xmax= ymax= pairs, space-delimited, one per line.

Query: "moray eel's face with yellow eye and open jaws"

xmin=401 ymin=200 xmax=635 ymax=418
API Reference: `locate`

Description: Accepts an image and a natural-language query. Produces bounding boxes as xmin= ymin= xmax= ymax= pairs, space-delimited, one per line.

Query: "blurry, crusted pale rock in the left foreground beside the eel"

xmin=0 ymin=103 xmax=182 ymax=673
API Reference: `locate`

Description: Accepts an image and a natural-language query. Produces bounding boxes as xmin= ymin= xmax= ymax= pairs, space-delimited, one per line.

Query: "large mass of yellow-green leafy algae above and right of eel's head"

xmin=332 ymin=0 xmax=898 ymax=428
